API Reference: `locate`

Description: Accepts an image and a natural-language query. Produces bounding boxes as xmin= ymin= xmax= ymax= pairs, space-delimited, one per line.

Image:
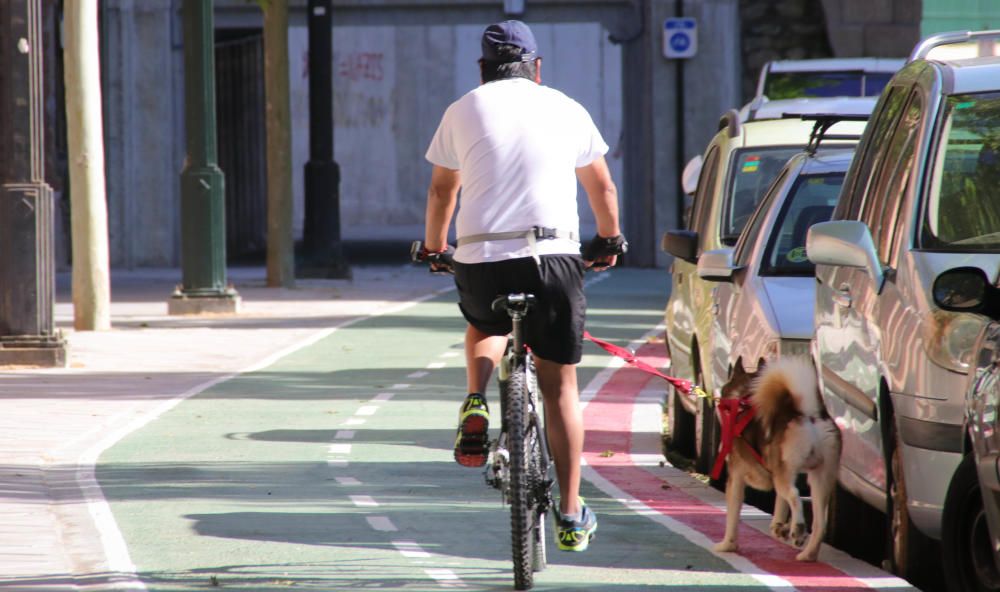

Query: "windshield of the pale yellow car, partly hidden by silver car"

xmin=722 ymin=146 xmax=802 ymax=246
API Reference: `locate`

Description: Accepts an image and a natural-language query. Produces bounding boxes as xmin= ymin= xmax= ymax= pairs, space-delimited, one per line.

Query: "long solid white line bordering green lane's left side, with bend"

xmin=79 ymin=286 xmax=455 ymax=590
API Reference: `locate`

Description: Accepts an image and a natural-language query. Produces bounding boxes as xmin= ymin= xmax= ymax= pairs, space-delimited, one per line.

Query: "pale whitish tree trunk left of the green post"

xmin=63 ymin=0 xmax=111 ymax=331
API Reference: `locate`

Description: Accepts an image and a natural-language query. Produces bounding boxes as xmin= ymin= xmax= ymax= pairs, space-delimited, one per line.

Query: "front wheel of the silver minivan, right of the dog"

xmin=886 ymin=417 xmax=928 ymax=580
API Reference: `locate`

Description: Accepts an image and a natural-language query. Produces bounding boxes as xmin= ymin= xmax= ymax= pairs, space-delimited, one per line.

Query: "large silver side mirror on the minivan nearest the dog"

xmin=806 ymin=220 xmax=885 ymax=292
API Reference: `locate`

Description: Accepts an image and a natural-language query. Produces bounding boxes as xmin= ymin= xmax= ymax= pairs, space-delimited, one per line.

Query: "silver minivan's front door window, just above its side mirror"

xmin=861 ymin=91 xmax=923 ymax=263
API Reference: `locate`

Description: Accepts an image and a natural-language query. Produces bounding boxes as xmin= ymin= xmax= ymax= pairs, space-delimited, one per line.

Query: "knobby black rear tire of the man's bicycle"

xmin=505 ymin=360 xmax=535 ymax=590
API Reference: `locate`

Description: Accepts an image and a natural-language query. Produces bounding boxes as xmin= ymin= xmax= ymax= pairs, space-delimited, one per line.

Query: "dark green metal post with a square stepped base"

xmin=168 ymin=0 xmax=240 ymax=314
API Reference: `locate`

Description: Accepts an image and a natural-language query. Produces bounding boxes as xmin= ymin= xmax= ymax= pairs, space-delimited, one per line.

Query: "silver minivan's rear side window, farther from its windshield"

xmin=835 ymin=86 xmax=908 ymax=220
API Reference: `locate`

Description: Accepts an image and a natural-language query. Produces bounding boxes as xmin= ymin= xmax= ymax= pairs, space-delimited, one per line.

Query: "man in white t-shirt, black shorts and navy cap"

xmin=424 ymin=20 xmax=625 ymax=551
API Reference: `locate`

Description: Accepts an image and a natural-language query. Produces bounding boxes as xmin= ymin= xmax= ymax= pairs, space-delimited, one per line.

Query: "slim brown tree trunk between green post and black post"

xmin=263 ymin=0 xmax=295 ymax=288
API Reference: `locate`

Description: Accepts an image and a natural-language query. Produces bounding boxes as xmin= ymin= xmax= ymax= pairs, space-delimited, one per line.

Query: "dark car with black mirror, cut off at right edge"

xmin=932 ymin=267 xmax=1000 ymax=592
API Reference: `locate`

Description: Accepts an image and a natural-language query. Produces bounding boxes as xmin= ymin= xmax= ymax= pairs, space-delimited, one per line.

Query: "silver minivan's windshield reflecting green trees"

xmin=920 ymin=92 xmax=1000 ymax=251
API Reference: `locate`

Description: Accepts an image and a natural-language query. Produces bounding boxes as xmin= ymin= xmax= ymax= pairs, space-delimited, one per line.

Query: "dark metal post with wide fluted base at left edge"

xmin=0 ymin=0 xmax=66 ymax=367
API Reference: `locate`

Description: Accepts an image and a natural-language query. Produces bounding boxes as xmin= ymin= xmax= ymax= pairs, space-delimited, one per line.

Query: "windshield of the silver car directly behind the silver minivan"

xmin=760 ymin=173 xmax=844 ymax=276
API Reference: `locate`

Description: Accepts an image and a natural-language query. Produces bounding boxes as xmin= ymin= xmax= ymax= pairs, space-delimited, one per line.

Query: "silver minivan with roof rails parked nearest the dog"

xmin=807 ymin=32 xmax=1000 ymax=577
